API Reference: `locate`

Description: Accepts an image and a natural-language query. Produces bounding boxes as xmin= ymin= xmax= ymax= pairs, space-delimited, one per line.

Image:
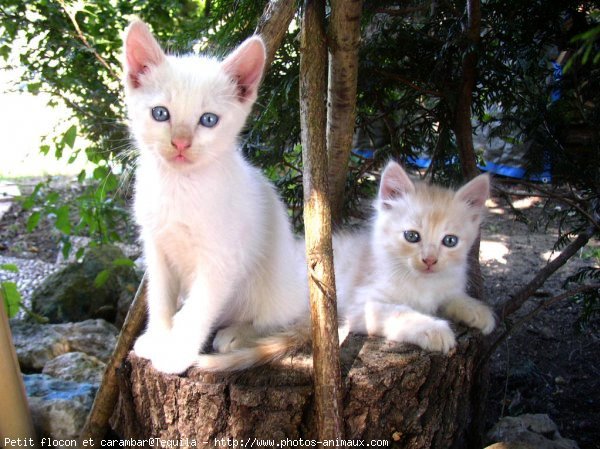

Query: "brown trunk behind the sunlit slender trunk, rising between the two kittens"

xmin=327 ymin=0 xmax=362 ymax=226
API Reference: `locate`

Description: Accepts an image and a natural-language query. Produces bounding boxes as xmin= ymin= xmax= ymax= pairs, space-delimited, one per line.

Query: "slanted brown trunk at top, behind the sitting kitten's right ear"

xmin=255 ymin=0 xmax=296 ymax=68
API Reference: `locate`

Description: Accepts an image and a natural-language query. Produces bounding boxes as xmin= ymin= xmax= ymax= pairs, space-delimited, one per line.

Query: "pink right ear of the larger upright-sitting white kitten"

xmin=223 ymin=36 xmax=267 ymax=103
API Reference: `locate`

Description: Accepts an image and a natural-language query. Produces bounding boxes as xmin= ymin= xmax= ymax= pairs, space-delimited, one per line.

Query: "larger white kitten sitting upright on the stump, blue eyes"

xmin=125 ymin=21 xmax=308 ymax=373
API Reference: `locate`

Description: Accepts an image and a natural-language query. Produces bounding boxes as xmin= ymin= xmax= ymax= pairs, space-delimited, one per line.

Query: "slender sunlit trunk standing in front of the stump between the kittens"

xmin=300 ymin=0 xmax=343 ymax=441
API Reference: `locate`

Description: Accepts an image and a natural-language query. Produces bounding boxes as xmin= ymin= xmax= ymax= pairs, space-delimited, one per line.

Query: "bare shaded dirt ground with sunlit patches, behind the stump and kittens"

xmin=0 ymin=177 xmax=600 ymax=449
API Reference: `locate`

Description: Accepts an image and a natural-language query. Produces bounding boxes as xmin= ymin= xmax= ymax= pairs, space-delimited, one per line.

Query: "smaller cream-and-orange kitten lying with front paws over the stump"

xmin=334 ymin=162 xmax=495 ymax=353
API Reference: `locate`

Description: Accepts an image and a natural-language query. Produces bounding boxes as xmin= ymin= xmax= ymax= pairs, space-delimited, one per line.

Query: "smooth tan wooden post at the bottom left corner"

xmin=0 ymin=292 xmax=38 ymax=449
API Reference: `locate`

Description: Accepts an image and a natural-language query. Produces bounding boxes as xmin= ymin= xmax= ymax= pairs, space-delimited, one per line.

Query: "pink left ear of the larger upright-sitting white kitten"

xmin=123 ymin=20 xmax=165 ymax=89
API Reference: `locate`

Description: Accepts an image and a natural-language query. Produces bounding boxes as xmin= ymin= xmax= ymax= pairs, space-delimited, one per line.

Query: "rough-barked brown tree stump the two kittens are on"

xmin=111 ymin=331 xmax=482 ymax=449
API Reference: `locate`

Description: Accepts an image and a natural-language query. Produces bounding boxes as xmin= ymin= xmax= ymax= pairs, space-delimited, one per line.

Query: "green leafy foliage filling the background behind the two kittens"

xmin=0 ymin=0 xmax=600 ymax=322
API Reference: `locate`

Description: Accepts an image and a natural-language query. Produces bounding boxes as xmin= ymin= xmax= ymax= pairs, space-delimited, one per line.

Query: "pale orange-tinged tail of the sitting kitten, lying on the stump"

xmin=194 ymin=326 xmax=311 ymax=371
